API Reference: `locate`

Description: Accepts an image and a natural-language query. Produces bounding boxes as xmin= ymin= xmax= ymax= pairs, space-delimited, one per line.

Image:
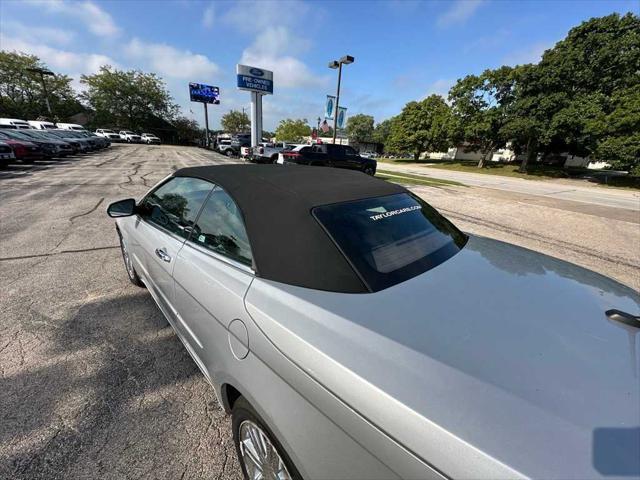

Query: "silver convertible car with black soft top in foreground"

xmin=108 ymin=165 xmax=640 ymax=479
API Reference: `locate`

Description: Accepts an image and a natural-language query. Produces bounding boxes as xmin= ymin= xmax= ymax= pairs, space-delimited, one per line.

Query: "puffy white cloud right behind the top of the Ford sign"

xmin=240 ymin=26 xmax=328 ymax=88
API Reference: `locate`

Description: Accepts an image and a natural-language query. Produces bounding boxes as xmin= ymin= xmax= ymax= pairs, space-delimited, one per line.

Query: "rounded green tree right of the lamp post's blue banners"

xmin=388 ymin=95 xmax=456 ymax=161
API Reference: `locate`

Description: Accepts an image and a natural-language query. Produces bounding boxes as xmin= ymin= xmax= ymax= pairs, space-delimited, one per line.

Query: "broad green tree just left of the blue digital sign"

xmin=80 ymin=65 xmax=178 ymax=130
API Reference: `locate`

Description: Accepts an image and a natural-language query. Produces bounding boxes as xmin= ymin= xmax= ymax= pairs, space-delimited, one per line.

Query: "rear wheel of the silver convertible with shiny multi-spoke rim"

xmin=231 ymin=397 xmax=302 ymax=480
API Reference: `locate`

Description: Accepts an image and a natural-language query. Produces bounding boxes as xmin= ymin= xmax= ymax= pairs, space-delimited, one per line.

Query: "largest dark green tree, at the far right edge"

xmin=503 ymin=13 xmax=640 ymax=171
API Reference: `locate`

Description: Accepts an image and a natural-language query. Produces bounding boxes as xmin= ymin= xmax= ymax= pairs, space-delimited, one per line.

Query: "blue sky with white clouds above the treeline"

xmin=0 ymin=0 xmax=638 ymax=129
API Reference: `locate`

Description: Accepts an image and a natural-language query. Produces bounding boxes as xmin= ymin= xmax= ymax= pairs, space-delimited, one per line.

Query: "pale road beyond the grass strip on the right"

xmin=379 ymin=163 xmax=640 ymax=212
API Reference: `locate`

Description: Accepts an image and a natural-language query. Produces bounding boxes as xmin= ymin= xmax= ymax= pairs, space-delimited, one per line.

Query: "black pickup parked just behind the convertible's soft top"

xmin=282 ymin=143 xmax=377 ymax=175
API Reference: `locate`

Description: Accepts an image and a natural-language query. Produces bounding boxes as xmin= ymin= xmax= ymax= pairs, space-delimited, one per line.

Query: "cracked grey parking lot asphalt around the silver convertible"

xmin=0 ymin=145 xmax=640 ymax=479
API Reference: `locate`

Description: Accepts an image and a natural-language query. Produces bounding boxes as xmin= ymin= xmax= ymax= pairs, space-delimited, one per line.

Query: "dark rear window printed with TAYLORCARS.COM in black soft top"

xmin=313 ymin=193 xmax=467 ymax=292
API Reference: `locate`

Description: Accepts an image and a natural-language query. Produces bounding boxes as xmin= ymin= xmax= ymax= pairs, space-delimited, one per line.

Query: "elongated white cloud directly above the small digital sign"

xmin=124 ymin=38 xmax=220 ymax=81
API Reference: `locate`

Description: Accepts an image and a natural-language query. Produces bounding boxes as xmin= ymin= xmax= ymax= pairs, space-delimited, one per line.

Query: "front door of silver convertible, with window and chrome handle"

xmin=133 ymin=177 xmax=213 ymax=320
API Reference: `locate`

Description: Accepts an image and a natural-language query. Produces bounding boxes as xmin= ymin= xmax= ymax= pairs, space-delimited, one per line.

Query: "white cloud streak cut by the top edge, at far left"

xmin=26 ymin=0 xmax=120 ymax=37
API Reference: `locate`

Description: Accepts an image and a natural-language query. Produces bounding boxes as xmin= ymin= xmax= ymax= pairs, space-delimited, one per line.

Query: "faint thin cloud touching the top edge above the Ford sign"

xmin=222 ymin=0 xmax=310 ymax=32
